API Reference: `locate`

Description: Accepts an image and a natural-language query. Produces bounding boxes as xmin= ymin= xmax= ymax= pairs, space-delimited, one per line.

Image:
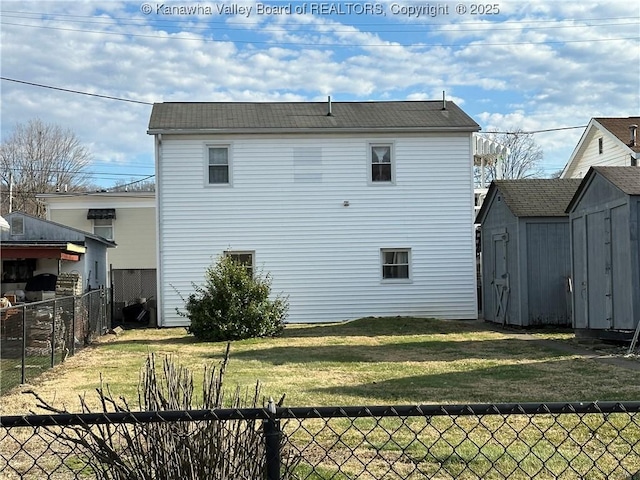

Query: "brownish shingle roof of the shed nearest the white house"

xmin=476 ymin=178 xmax=581 ymax=223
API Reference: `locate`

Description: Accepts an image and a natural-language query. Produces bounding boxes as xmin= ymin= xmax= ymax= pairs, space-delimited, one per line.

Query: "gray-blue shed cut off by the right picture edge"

xmin=567 ymin=167 xmax=640 ymax=338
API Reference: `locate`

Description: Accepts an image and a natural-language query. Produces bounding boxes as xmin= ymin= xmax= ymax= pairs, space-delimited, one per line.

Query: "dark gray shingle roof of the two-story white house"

xmin=148 ymin=101 xmax=480 ymax=134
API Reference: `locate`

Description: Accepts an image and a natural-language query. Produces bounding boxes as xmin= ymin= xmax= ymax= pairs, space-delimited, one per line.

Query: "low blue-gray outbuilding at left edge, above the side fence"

xmin=0 ymin=212 xmax=116 ymax=294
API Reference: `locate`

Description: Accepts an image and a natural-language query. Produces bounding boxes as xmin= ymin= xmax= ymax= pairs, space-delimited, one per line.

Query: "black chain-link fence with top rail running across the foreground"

xmin=0 ymin=402 xmax=640 ymax=480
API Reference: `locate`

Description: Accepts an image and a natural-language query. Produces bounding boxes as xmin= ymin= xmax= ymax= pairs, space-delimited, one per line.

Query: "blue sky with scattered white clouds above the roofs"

xmin=0 ymin=0 xmax=640 ymax=187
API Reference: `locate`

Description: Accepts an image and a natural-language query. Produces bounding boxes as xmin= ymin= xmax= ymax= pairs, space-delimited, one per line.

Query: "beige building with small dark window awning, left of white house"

xmin=38 ymin=192 xmax=157 ymax=321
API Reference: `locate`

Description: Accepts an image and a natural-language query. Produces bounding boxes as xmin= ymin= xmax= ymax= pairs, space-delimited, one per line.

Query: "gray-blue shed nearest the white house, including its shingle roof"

xmin=476 ymin=179 xmax=580 ymax=327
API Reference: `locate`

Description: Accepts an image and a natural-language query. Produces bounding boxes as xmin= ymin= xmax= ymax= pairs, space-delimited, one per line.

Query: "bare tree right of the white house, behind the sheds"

xmin=475 ymin=128 xmax=544 ymax=188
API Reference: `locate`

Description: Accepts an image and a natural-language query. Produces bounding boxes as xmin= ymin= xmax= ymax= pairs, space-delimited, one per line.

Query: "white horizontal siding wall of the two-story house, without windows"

xmin=158 ymin=134 xmax=477 ymax=326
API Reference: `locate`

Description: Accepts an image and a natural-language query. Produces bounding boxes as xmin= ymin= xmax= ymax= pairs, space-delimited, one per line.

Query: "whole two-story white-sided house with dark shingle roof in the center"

xmin=148 ymin=101 xmax=479 ymax=326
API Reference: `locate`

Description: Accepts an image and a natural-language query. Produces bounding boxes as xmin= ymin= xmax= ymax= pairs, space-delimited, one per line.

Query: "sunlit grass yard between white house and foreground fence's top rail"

xmin=1 ymin=317 xmax=640 ymax=413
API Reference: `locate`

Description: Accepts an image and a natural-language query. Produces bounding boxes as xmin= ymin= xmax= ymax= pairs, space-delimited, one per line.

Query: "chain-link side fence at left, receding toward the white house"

xmin=0 ymin=290 xmax=111 ymax=395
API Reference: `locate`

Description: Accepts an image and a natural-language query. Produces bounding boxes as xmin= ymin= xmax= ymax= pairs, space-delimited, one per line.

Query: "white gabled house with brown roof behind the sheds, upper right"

xmin=561 ymin=117 xmax=640 ymax=178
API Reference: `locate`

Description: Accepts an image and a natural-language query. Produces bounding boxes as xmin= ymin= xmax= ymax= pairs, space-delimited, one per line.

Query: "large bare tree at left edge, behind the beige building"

xmin=0 ymin=118 xmax=91 ymax=217
